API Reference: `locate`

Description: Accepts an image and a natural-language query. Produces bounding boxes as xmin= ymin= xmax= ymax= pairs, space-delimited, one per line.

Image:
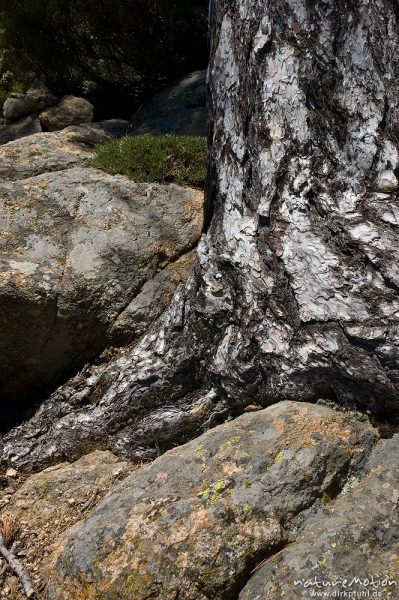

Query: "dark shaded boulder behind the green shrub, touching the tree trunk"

xmin=130 ymin=71 xmax=206 ymax=136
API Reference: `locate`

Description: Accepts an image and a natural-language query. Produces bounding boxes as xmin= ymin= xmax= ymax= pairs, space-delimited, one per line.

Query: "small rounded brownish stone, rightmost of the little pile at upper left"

xmin=39 ymin=96 xmax=94 ymax=131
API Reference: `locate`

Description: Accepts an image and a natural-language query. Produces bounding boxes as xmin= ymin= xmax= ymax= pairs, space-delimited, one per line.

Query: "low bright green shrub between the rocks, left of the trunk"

xmin=93 ymin=135 xmax=206 ymax=188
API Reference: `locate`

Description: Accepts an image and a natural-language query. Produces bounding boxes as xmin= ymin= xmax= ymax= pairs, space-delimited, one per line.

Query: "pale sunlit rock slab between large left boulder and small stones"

xmin=0 ymin=117 xmax=127 ymax=180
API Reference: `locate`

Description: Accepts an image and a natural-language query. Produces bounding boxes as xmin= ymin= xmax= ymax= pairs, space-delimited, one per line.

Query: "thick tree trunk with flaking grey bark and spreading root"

xmin=3 ymin=0 xmax=399 ymax=469
